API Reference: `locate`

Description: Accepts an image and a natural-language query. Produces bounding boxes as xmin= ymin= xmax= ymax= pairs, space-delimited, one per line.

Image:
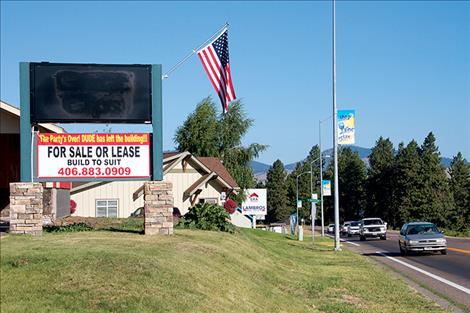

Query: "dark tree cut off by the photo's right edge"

xmin=449 ymin=152 xmax=470 ymax=230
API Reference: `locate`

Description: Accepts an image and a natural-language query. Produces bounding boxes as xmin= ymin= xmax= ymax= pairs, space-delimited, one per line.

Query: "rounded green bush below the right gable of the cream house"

xmin=178 ymin=203 xmax=235 ymax=233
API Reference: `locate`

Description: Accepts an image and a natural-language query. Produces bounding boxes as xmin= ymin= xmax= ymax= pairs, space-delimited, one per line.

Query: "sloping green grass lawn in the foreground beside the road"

xmin=0 ymin=230 xmax=443 ymax=313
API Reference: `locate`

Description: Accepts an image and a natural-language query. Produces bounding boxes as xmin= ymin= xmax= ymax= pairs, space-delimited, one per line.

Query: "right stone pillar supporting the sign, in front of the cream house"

xmin=144 ymin=181 xmax=173 ymax=235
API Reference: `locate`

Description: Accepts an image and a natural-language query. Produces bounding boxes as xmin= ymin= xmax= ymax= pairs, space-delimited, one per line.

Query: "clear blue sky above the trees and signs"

xmin=1 ymin=1 xmax=470 ymax=163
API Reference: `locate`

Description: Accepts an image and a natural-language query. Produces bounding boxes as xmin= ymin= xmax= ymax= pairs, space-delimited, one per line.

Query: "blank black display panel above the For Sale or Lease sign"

xmin=30 ymin=63 xmax=152 ymax=123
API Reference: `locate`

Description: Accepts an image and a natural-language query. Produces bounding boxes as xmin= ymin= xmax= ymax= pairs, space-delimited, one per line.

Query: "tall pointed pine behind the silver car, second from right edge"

xmin=418 ymin=132 xmax=455 ymax=227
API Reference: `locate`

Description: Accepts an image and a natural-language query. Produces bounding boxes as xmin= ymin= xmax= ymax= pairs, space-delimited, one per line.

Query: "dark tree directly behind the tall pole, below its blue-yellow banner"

xmin=325 ymin=147 xmax=366 ymax=221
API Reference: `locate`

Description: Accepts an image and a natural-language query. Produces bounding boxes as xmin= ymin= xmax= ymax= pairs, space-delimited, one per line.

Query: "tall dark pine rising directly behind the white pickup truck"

xmin=366 ymin=137 xmax=397 ymax=226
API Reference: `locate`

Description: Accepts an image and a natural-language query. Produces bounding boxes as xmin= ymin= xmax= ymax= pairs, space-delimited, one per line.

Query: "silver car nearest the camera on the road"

xmin=398 ymin=222 xmax=447 ymax=255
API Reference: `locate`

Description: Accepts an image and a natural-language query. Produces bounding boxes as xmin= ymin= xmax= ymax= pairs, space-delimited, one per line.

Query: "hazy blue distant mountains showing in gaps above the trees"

xmin=251 ymin=146 xmax=458 ymax=181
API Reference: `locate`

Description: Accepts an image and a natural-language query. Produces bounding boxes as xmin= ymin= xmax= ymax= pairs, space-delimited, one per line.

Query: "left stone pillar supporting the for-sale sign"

xmin=10 ymin=183 xmax=43 ymax=235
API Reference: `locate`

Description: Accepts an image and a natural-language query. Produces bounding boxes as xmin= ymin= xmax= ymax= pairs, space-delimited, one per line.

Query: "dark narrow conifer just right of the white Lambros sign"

xmin=266 ymin=160 xmax=290 ymax=222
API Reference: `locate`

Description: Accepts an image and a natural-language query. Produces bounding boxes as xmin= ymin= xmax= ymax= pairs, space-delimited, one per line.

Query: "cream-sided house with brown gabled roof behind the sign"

xmin=71 ymin=151 xmax=251 ymax=227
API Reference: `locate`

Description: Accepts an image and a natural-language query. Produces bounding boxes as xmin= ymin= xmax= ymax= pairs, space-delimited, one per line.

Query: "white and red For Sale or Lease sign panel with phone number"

xmin=36 ymin=133 xmax=151 ymax=181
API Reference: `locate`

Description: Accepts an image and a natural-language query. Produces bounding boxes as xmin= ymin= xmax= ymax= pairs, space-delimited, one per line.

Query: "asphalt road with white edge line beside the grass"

xmin=330 ymin=232 xmax=470 ymax=310
